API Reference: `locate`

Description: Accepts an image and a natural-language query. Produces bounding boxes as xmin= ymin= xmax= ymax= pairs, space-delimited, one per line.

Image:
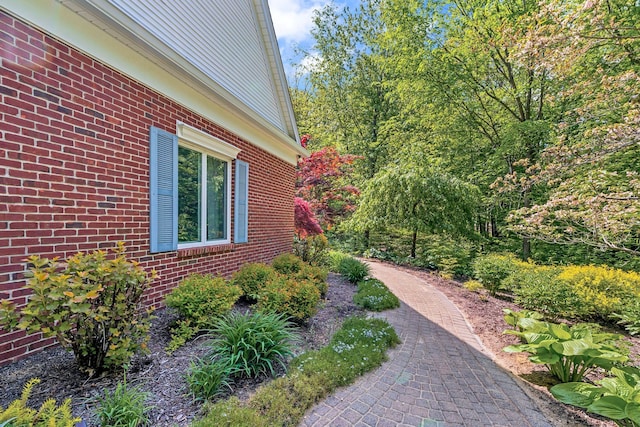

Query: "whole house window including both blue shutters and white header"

xmin=150 ymin=123 xmax=248 ymax=252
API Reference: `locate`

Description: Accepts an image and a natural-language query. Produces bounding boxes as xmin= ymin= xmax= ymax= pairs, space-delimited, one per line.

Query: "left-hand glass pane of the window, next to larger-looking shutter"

xmin=178 ymin=147 xmax=202 ymax=243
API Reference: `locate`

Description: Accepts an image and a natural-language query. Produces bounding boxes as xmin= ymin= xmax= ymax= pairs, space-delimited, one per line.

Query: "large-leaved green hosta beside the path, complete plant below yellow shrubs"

xmin=504 ymin=317 xmax=627 ymax=383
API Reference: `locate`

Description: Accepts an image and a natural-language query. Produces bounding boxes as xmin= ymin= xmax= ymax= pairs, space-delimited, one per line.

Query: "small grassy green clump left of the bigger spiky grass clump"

xmin=186 ymin=360 xmax=236 ymax=400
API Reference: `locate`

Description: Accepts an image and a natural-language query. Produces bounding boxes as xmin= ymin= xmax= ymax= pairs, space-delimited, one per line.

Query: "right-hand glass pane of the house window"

xmin=207 ymin=157 xmax=227 ymax=240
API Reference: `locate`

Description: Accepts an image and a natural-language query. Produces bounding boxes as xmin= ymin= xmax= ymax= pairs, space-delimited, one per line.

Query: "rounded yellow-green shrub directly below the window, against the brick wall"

xmin=166 ymin=274 xmax=242 ymax=351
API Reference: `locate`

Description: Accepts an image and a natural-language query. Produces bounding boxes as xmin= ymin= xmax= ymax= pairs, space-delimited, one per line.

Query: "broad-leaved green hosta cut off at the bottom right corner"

xmin=550 ymin=366 xmax=640 ymax=427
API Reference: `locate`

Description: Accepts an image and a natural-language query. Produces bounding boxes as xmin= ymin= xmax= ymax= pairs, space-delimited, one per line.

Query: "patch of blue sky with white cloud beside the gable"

xmin=268 ymin=0 xmax=360 ymax=83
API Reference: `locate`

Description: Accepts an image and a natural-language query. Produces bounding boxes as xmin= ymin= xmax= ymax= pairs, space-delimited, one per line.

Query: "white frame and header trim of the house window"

xmin=176 ymin=122 xmax=240 ymax=249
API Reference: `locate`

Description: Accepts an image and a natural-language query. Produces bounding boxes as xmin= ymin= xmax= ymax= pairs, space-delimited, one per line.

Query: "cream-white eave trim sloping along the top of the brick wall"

xmin=0 ymin=0 xmax=308 ymax=165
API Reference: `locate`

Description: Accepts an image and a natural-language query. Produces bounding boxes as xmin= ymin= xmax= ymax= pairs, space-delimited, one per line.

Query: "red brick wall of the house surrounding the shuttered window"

xmin=0 ymin=12 xmax=295 ymax=365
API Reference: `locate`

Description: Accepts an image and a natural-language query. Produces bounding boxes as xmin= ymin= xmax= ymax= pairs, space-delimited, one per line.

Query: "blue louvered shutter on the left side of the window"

xmin=149 ymin=127 xmax=178 ymax=252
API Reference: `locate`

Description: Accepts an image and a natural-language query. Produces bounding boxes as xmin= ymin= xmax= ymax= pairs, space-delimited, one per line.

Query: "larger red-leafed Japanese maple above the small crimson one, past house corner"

xmin=296 ymin=147 xmax=360 ymax=229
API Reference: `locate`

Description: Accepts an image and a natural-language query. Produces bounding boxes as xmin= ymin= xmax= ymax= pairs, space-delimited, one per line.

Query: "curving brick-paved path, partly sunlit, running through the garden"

xmin=301 ymin=263 xmax=552 ymax=427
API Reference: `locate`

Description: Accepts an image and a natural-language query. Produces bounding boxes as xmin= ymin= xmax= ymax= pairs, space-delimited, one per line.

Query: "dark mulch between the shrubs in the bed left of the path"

xmin=0 ymin=274 xmax=363 ymax=427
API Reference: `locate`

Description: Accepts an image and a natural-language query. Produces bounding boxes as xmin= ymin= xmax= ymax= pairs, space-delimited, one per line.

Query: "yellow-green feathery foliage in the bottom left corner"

xmin=0 ymin=378 xmax=80 ymax=427
